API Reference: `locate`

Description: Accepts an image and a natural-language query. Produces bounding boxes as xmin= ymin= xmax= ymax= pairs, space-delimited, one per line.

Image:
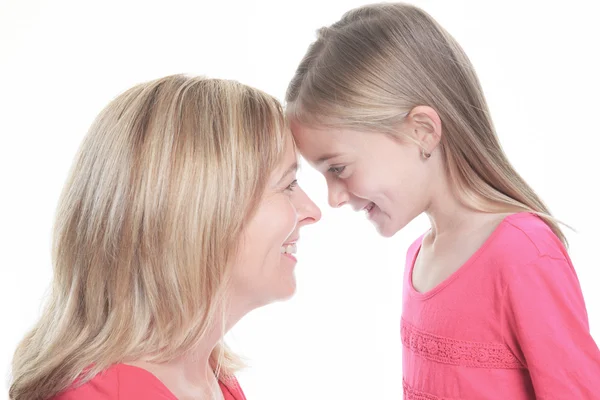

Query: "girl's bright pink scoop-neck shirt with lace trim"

xmin=401 ymin=213 xmax=600 ymax=400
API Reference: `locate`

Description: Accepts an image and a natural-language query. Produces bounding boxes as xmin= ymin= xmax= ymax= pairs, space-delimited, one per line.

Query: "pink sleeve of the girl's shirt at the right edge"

xmin=503 ymin=256 xmax=600 ymax=400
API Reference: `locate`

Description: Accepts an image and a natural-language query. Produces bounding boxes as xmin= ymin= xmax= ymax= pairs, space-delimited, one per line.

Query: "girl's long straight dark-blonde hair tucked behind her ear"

xmin=286 ymin=3 xmax=566 ymax=245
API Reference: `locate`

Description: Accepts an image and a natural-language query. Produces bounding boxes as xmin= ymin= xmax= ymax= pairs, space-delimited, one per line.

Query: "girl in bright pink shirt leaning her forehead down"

xmin=286 ymin=4 xmax=600 ymax=400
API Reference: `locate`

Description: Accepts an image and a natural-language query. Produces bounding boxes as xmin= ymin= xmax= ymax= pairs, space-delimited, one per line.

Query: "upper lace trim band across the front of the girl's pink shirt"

xmin=401 ymin=319 xmax=525 ymax=370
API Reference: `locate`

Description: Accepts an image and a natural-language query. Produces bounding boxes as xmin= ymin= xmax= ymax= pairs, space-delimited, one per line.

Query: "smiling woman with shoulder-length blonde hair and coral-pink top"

xmin=10 ymin=76 xmax=320 ymax=400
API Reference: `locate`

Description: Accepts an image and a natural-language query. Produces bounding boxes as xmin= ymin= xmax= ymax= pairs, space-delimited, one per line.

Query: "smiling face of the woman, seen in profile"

xmin=233 ymin=140 xmax=321 ymax=308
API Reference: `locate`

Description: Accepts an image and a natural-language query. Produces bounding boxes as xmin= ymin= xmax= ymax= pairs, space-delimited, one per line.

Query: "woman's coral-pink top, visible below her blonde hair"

xmin=53 ymin=364 xmax=246 ymax=400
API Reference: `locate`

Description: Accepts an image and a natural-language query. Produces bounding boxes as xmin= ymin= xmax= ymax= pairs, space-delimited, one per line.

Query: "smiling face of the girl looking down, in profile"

xmin=292 ymin=122 xmax=434 ymax=237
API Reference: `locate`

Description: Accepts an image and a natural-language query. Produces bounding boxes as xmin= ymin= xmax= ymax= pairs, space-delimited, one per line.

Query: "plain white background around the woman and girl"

xmin=0 ymin=0 xmax=600 ymax=400
